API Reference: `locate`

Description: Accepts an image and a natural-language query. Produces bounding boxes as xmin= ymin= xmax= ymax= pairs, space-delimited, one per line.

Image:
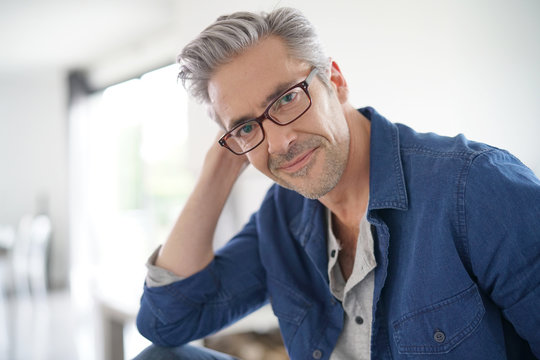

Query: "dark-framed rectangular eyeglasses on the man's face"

xmin=218 ymin=68 xmax=317 ymax=155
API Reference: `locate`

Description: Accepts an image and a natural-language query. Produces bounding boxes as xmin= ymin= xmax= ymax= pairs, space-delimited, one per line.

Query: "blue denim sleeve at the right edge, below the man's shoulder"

xmin=462 ymin=150 xmax=540 ymax=358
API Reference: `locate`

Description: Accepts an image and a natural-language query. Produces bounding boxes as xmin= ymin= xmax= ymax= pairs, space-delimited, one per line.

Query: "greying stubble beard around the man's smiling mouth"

xmin=268 ymin=136 xmax=349 ymax=199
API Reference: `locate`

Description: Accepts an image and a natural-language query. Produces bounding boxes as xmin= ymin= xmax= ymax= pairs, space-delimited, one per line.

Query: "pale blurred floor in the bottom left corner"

xmin=0 ymin=291 xmax=148 ymax=360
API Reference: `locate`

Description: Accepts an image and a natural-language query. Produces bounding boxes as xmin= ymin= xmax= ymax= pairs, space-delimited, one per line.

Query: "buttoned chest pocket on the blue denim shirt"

xmin=392 ymin=284 xmax=485 ymax=354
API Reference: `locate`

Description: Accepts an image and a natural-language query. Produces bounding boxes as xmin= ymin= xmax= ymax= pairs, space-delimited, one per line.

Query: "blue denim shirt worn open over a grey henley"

xmin=137 ymin=108 xmax=540 ymax=360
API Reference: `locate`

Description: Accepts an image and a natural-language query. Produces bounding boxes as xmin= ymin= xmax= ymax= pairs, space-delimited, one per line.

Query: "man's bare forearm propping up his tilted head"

xmin=152 ymin=142 xmax=246 ymax=277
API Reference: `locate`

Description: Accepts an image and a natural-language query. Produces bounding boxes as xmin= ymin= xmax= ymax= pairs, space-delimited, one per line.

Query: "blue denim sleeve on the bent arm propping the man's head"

xmin=137 ymin=211 xmax=267 ymax=346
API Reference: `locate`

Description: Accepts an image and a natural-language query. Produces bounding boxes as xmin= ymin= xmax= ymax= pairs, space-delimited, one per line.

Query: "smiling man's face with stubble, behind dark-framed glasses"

xmin=208 ymin=37 xmax=350 ymax=199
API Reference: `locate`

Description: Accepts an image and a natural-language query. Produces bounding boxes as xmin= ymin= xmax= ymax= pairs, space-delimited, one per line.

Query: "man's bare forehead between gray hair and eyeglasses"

xmin=208 ymin=37 xmax=309 ymax=129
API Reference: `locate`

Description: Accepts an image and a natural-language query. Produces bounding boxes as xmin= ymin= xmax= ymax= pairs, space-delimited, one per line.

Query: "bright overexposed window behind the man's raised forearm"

xmin=72 ymin=66 xmax=194 ymax=268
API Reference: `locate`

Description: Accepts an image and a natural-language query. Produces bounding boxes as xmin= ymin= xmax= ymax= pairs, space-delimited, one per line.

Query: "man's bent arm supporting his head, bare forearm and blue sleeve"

xmin=137 ymin=139 xmax=266 ymax=346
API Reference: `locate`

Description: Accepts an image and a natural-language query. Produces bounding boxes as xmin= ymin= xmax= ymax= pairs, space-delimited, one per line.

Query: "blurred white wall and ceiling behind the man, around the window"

xmin=0 ymin=0 xmax=540 ymax=310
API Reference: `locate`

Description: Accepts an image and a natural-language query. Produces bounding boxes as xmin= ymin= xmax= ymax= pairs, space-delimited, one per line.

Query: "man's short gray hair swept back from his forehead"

xmin=177 ymin=8 xmax=329 ymax=104
